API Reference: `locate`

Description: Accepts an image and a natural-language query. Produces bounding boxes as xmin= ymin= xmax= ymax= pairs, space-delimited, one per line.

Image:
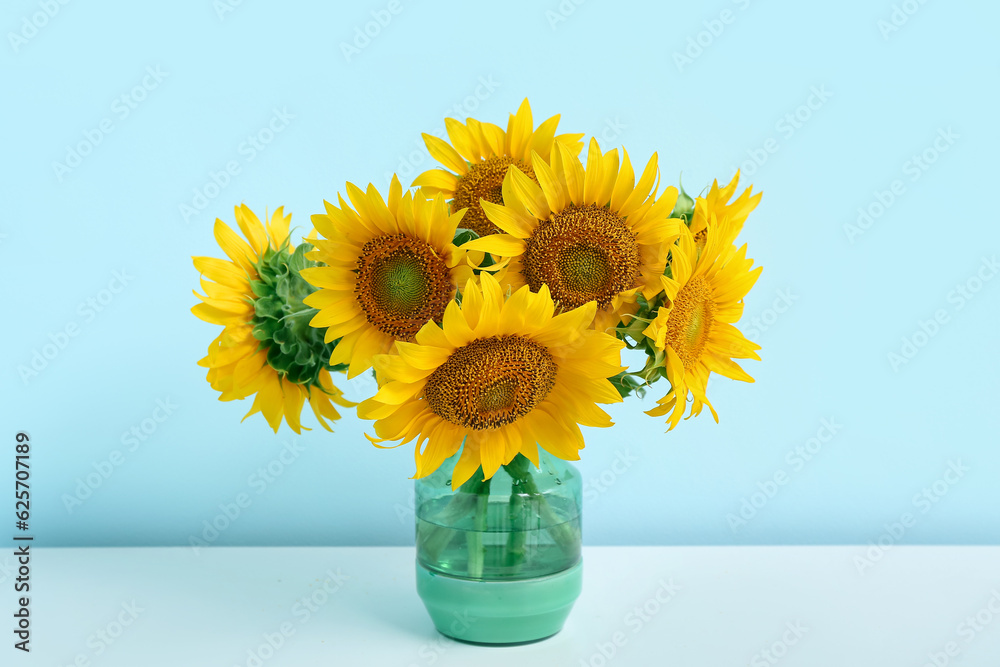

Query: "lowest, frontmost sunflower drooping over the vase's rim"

xmin=358 ymin=273 xmax=623 ymax=488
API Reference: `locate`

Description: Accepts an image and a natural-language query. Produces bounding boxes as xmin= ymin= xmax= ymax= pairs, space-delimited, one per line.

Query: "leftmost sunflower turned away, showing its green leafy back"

xmin=191 ymin=205 xmax=354 ymax=433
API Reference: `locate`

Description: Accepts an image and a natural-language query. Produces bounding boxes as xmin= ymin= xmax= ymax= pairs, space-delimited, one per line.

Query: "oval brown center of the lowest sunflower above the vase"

xmin=424 ymin=334 xmax=557 ymax=431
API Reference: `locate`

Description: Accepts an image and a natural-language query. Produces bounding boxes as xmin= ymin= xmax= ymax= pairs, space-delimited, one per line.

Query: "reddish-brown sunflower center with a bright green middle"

xmin=354 ymin=234 xmax=454 ymax=340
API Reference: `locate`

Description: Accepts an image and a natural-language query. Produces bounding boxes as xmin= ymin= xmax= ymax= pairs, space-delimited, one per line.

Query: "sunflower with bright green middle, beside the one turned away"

xmin=302 ymin=176 xmax=472 ymax=378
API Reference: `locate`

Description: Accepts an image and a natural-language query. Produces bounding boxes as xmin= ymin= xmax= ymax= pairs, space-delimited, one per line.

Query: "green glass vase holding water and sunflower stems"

xmin=416 ymin=449 xmax=583 ymax=644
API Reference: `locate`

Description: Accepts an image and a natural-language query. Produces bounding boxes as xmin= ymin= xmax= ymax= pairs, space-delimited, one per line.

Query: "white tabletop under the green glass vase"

xmin=13 ymin=546 xmax=1000 ymax=667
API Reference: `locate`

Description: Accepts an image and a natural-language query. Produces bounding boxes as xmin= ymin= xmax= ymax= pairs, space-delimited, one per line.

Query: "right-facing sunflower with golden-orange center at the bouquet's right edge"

xmin=645 ymin=216 xmax=762 ymax=430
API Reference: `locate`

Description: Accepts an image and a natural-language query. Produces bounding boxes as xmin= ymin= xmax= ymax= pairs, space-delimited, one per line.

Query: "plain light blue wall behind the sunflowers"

xmin=0 ymin=0 xmax=1000 ymax=545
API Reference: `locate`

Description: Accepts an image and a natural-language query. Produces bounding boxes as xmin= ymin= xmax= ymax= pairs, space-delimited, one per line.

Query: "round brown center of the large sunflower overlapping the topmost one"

xmin=521 ymin=204 xmax=639 ymax=308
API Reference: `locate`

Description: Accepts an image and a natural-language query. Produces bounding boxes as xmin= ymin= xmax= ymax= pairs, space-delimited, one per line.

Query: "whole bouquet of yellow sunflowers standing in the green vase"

xmin=193 ymin=100 xmax=761 ymax=640
